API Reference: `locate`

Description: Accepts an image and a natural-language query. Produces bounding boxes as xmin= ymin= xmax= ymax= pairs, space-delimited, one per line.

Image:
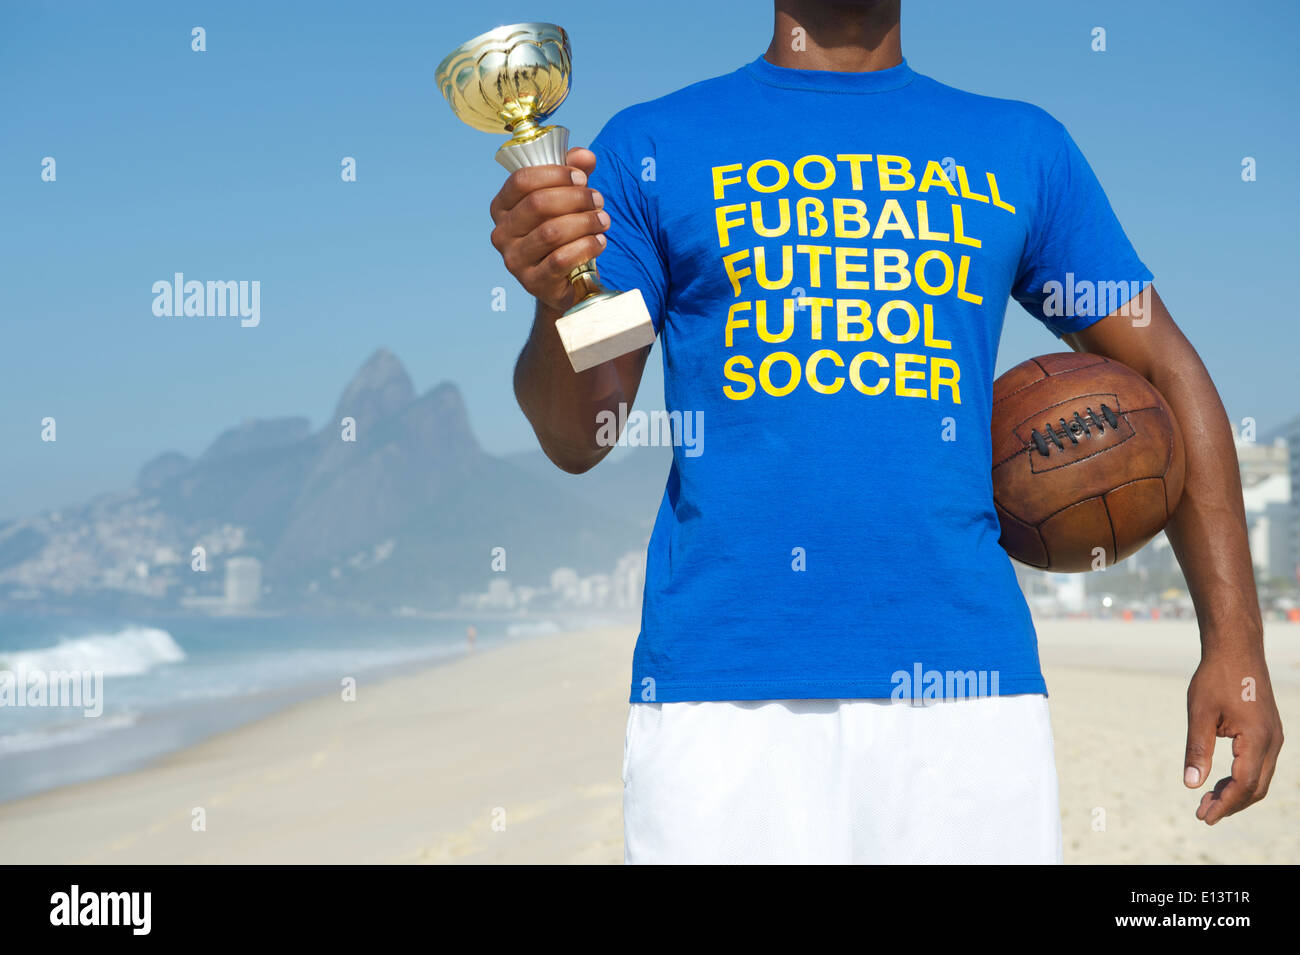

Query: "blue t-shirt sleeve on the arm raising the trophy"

xmin=588 ymin=117 xmax=668 ymax=333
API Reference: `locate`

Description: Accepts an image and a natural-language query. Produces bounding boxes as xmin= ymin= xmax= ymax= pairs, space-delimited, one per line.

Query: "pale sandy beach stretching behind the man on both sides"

xmin=0 ymin=621 xmax=1300 ymax=864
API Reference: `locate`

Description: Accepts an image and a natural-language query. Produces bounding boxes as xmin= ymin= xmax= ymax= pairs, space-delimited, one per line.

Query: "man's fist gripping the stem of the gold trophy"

xmin=490 ymin=148 xmax=610 ymax=312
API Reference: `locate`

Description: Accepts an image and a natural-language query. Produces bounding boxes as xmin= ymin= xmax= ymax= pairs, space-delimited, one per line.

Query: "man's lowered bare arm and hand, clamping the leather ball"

xmin=1065 ymin=287 xmax=1282 ymax=825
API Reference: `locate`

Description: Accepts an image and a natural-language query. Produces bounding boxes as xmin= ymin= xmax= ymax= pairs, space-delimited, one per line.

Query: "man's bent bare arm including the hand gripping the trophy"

xmin=491 ymin=148 xmax=650 ymax=474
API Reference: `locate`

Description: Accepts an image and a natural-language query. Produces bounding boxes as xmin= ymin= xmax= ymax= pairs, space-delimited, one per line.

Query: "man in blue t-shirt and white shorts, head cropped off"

xmin=491 ymin=0 xmax=1282 ymax=863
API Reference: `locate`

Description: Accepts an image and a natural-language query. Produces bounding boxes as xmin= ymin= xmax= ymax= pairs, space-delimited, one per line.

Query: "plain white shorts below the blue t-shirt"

xmin=623 ymin=695 xmax=1061 ymax=864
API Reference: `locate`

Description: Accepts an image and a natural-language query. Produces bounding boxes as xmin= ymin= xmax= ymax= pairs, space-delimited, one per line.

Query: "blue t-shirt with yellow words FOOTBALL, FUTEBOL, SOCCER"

xmin=592 ymin=57 xmax=1151 ymax=702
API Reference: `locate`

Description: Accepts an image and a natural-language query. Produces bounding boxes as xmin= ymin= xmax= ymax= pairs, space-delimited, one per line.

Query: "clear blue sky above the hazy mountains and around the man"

xmin=0 ymin=0 xmax=1300 ymax=518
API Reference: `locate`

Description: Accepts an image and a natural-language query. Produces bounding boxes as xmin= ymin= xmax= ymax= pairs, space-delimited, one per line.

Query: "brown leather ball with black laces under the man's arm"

xmin=993 ymin=352 xmax=1183 ymax=572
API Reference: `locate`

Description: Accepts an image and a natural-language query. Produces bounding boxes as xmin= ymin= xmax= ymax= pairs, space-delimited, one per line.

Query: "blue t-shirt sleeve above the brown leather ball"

xmin=1011 ymin=121 xmax=1152 ymax=335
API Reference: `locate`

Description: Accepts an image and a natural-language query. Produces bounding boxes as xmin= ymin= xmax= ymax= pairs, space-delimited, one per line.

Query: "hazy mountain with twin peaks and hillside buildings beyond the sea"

xmin=0 ymin=351 xmax=668 ymax=613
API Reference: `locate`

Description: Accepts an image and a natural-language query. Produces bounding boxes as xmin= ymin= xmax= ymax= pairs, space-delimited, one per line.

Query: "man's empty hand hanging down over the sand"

xmin=1183 ymin=648 xmax=1282 ymax=825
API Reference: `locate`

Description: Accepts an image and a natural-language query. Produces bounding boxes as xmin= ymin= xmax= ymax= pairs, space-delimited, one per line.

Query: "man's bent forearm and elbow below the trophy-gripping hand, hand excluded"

xmin=515 ymin=303 xmax=650 ymax=474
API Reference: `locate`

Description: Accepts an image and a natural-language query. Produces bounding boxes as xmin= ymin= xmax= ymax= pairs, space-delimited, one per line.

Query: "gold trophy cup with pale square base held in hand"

xmin=434 ymin=23 xmax=654 ymax=372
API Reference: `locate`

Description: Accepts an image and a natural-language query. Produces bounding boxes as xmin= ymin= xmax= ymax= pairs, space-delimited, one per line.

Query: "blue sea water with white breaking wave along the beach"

xmin=0 ymin=616 xmax=519 ymax=800
